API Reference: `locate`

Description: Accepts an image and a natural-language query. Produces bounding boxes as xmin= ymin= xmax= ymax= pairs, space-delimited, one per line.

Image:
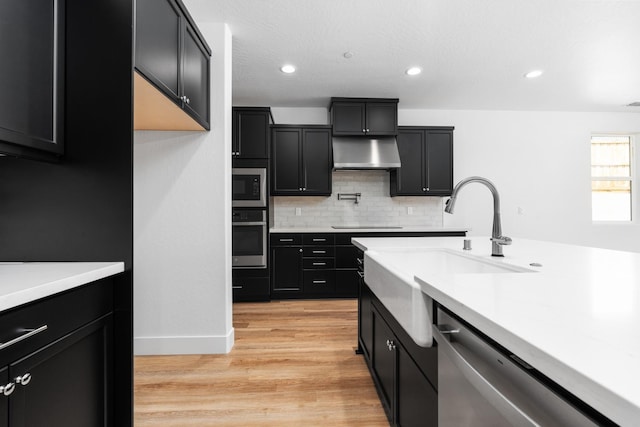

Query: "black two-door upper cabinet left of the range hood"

xmin=271 ymin=125 xmax=333 ymax=196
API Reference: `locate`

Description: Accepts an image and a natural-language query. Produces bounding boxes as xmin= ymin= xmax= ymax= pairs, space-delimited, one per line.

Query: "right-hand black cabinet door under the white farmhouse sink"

xmin=396 ymin=346 xmax=438 ymax=427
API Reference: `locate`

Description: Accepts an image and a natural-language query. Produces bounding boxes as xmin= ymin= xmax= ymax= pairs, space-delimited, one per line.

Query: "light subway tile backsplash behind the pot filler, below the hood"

xmin=271 ymin=170 xmax=443 ymax=228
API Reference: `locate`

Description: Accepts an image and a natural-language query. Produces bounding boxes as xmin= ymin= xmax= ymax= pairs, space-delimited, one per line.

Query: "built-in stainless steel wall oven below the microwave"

xmin=231 ymin=208 xmax=267 ymax=268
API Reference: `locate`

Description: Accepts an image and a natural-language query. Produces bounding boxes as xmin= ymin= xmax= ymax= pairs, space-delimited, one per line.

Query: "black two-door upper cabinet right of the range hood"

xmin=389 ymin=126 xmax=453 ymax=196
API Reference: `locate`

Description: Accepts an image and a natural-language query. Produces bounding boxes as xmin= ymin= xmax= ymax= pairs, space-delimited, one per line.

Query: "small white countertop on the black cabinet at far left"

xmin=0 ymin=262 xmax=124 ymax=311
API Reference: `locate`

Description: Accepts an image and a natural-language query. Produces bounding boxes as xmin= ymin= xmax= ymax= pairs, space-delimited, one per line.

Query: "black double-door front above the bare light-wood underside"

xmin=135 ymin=0 xmax=211 ymax=130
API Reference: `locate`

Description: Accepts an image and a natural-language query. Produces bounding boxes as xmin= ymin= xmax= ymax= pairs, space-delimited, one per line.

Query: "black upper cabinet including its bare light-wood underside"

xmin=134 ymin=0 xmax=211 ymax=130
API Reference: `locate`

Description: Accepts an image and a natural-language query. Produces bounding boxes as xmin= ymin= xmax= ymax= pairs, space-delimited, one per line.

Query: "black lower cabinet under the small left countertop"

xmin=0 ymin=278 xmax=115 ymax=427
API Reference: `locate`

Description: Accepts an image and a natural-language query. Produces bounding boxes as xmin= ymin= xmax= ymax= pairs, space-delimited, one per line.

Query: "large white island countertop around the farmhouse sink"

xmin=353 ymin=237 xmax=640 ymax=426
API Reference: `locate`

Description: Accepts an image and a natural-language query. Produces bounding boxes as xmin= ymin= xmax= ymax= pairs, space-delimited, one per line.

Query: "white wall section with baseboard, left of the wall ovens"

xmin=133 ymin=24 xmax=234 ymax=355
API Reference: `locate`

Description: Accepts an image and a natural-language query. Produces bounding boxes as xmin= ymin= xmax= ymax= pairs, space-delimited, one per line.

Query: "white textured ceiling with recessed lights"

xmin=184 ymin=0 xmax=640 ymax=113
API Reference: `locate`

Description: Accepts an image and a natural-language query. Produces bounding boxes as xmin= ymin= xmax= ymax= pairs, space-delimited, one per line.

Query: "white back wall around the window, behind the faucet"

xmin=398 ymin=110 xmax=640 ymax=252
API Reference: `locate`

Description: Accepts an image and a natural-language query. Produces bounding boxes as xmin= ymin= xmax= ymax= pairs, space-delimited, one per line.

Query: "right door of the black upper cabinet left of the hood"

xmin=302 ymin=129 xmax=332 ymax=195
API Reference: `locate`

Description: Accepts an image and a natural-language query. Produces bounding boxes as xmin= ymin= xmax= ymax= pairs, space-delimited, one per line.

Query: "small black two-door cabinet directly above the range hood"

xmin=329 ymin=98 xmax=398 ymax=136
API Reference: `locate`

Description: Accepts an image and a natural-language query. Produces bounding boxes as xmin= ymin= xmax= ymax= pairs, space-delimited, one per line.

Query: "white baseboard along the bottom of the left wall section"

xmin=133 ymin=328 xmax=234 ymax=356
